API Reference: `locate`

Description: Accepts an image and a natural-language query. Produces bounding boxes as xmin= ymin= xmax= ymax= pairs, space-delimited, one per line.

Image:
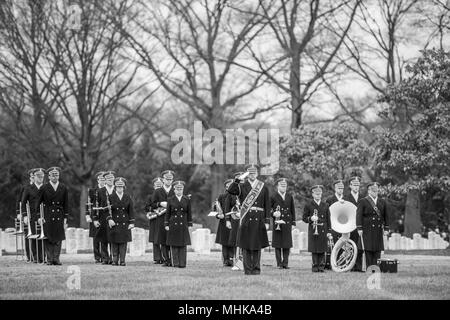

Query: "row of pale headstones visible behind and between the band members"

xmin=0 ymin=222 xmax=449 ymax=256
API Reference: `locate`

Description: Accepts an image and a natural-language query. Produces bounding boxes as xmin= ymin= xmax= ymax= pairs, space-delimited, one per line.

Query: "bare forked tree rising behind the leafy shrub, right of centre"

xmin=253 ymin=0 xmax=361 ymax=128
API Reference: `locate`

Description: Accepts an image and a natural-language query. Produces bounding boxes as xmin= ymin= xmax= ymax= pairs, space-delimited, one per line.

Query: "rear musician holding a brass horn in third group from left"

xmin=152 ymin=170 xmax=175 ymax=267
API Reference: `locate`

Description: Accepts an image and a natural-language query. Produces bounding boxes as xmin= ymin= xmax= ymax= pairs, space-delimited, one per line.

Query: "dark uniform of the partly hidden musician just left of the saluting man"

xmin=216 ymin=193 xmax=239 ymax=267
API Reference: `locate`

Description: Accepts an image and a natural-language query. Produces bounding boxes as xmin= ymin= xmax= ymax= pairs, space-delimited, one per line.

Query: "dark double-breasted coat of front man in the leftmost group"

xmin=38 ymin=182 xmax=69 ymax=242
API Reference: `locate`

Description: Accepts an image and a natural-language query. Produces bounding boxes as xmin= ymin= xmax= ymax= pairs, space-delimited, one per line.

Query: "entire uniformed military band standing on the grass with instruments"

xmin=16 ymin=165 xmax=389 ymax=275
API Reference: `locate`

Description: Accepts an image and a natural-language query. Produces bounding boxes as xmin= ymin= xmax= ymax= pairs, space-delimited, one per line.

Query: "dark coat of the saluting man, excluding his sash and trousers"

xmin=228 ymin=179 xmax=271 ymax=250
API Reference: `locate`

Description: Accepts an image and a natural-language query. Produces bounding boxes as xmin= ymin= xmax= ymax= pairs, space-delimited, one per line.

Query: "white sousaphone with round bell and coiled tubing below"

xmin=330 ymin=201 xmax=358 ymax=272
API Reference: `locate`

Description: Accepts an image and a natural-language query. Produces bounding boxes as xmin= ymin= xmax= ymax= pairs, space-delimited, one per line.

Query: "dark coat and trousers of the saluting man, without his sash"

xmin=228 ymin=179 xmax=270 ymax=274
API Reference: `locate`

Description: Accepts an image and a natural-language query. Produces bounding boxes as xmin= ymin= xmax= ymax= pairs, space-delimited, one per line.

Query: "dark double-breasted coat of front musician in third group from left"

xmin=163 ymin=195 xmax=192 ymax=247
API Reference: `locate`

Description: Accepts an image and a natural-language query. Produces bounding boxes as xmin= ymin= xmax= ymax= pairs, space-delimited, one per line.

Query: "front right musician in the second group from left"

xmin=106 ymin=177 xmax=135 ymax=266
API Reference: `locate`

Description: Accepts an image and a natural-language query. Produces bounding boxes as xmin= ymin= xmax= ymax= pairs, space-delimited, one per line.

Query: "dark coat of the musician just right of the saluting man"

xmin=270 ymin=191 xmax=295 ymax=248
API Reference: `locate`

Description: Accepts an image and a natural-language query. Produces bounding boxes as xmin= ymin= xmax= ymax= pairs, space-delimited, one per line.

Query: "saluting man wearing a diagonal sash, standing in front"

xmin=228 ymin=165 xmax=270 ymax=275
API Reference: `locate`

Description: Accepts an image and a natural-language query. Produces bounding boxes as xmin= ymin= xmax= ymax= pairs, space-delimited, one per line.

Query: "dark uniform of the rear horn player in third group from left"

xmin=151 ymin=187 xmax=175 ymax=266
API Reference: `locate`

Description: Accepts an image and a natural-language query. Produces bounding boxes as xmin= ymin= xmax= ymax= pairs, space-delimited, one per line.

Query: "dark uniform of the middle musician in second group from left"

xmin=92 ymin=186 xmax=114 ymax=264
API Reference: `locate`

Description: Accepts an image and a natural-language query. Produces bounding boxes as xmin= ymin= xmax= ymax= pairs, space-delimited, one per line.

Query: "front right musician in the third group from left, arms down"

xmin=164 ymin=181 xmax=192 ymax=268
